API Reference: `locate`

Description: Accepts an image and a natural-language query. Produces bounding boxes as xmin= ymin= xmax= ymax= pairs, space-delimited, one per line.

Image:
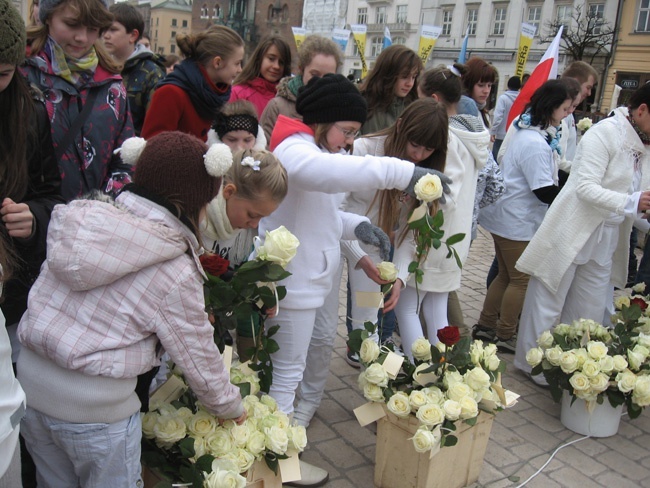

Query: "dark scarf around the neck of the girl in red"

xmin=158 ymin=59 xmax=230 ymax=120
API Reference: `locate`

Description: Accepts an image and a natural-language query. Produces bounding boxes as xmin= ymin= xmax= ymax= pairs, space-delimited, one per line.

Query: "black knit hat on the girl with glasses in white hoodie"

xmin=296 ymin=74 xmax=368 ymax=124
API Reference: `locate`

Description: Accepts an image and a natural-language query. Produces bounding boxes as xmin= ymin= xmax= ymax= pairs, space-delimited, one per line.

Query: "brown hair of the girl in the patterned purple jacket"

xmin=27 ymin=0 xmax=122 ymax=74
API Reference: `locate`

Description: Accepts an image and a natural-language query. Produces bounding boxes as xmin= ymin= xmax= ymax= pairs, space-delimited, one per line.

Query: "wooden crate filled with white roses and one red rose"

xmin=349 ymin=324 xmax=516 ymax=488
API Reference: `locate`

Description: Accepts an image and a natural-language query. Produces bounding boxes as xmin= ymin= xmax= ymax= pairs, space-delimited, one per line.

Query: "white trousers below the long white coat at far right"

xmin=514 ymin=260 xmax=612 ymax=373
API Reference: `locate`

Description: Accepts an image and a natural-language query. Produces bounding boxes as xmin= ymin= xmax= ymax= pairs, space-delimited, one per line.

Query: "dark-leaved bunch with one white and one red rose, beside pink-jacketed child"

xmin=201 ymin=226 xmax=300 ymax=392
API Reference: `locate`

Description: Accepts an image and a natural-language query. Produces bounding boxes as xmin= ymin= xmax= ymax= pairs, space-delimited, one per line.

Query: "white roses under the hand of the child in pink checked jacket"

xmin=142 ymin=364 xmax=307 ymax=488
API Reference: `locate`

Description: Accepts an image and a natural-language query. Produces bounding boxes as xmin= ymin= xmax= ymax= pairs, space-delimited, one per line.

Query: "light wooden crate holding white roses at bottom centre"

xmin=375 ymin=411 xmax=493 ymax=488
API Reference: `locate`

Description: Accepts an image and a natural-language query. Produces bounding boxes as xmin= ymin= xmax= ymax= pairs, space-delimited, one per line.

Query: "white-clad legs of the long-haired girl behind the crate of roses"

xmin=395 ymin=286 xmax=449 ymax=361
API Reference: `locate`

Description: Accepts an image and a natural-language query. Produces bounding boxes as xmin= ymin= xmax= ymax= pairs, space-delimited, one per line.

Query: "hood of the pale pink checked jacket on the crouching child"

xmin=47 ymin=192 xmax=192 ymax=291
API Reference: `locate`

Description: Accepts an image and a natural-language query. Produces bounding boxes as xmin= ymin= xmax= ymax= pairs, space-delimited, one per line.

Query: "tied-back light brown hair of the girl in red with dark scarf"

xmin=176 ymin=25 xmax=244 ymax=65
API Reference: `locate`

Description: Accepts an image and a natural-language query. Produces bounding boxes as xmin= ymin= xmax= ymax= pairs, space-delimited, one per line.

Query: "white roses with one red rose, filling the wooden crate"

xmin=348 ymin=323 xmax=506 ymax=452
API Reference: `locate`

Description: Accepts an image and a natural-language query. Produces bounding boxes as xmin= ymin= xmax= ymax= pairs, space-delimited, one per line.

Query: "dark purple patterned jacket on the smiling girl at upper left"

xmin=22 ymin=52 xmax=134 ymax=201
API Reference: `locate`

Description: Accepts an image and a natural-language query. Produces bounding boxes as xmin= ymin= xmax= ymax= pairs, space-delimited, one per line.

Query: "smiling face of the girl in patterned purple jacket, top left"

xmin=47 ymin=5 xmax=99 ymax=59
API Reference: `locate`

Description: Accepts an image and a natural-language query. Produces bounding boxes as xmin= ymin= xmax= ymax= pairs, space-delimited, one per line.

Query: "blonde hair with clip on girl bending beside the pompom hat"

xmin=224 ymin=149 xmax=289 ymax=203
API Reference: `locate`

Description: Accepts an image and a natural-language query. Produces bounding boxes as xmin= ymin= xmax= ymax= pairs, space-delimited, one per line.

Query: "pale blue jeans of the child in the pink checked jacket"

xmin=20 ymin=407 xmax=142 ymax=488
